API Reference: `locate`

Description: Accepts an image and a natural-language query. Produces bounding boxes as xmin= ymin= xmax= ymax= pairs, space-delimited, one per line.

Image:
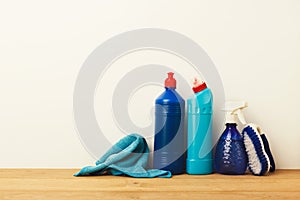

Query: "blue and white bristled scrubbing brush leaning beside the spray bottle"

xmin=243 ymin=124 xmax=275 ymax=176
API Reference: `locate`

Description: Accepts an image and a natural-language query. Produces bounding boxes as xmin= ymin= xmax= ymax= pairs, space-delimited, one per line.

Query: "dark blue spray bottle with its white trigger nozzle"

xmin=214 ymin=101 xmax=248 ymax=175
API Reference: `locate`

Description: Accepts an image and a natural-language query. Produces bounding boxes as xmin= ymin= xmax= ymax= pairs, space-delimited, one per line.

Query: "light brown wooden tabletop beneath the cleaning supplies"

xmin=0 ymin=169 xmax=300 ymax=200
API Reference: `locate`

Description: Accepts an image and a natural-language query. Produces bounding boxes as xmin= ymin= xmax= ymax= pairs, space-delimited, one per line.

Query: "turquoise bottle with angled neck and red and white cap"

xmin=186 ymin=78 xmax=213 ymax=174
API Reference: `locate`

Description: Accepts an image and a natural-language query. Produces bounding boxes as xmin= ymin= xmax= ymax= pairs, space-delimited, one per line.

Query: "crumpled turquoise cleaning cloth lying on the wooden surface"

xmin=74 ymin=134 xmax=172 ymax=178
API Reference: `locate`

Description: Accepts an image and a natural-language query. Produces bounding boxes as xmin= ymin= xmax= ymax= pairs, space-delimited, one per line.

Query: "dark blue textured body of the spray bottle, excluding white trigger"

xmin=214 ymin=123 xmax=248 ymax=175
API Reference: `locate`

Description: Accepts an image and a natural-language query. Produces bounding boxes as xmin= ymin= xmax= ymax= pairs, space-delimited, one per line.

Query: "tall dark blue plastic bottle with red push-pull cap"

xmin=153 ymin=72 xmax=185 ymax=174
